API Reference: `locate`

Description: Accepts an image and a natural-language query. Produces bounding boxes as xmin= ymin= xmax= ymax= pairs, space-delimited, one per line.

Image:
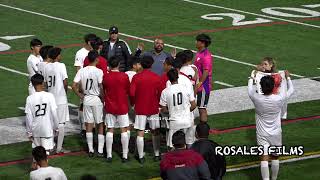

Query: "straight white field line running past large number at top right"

xmin=181 ymin=0 xmax=320 ymax=28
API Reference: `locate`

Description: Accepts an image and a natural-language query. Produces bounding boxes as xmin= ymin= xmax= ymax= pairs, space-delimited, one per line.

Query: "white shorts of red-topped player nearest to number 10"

xmin=134 ymin=114 xmax=160 ymax=131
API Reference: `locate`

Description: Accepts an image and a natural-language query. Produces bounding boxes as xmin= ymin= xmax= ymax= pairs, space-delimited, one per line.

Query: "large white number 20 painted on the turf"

xmin=201 ymin=4 xmax=320 ymax=26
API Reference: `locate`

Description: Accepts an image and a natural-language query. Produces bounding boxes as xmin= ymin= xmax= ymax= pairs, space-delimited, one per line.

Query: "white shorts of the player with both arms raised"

xmin=257 ymin=133 xmax=282 ymax=155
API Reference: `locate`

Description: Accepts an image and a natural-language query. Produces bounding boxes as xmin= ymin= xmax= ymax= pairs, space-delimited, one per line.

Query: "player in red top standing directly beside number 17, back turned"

xmin=103 ymin=56 xmax=130 ymax=163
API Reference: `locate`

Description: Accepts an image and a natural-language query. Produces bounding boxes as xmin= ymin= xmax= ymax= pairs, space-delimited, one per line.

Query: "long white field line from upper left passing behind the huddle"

xmin=0 ymin=3 xmax=303 ymax=77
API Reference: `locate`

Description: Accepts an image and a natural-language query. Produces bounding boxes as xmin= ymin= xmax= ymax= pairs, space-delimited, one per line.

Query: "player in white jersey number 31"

xmin=44 ymin=47 xmax=70 ymax=153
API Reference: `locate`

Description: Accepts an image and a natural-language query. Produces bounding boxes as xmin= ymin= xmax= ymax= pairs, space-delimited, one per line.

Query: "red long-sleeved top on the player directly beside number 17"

xmin=103 ymin=71 xmax=130 ymax=115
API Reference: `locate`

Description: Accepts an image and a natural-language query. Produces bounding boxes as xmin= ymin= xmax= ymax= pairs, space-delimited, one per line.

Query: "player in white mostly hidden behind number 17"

xmin=74 ymin=34 xmax=97 ymax=136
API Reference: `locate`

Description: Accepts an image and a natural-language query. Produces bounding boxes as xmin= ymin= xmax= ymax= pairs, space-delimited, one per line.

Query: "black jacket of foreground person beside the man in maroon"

xmin=191 ymin=139 xmax=226 ymax=179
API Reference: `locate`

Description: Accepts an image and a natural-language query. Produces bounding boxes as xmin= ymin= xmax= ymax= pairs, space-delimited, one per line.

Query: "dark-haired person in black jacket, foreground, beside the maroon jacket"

xmin=191 ymin=123 xmax=226 ymax=180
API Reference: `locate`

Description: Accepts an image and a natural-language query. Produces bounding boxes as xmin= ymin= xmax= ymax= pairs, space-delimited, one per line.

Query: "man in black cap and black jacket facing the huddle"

xmin=100 ymin=26 xmax=131 ymax=72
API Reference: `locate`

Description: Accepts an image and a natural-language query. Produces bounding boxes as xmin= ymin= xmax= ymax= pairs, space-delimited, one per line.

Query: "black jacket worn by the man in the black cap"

xmin=100 ymin=39 xmax=130 ymax=72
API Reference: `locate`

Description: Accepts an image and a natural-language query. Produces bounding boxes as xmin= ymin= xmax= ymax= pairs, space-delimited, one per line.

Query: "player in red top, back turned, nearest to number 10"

xmin=130 ymin=56 xmax=161 ymax=164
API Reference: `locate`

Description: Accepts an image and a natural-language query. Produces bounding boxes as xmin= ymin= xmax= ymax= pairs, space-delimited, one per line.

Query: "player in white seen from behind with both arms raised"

xmin=248 ymin=71 xmax=293 ymax=180
